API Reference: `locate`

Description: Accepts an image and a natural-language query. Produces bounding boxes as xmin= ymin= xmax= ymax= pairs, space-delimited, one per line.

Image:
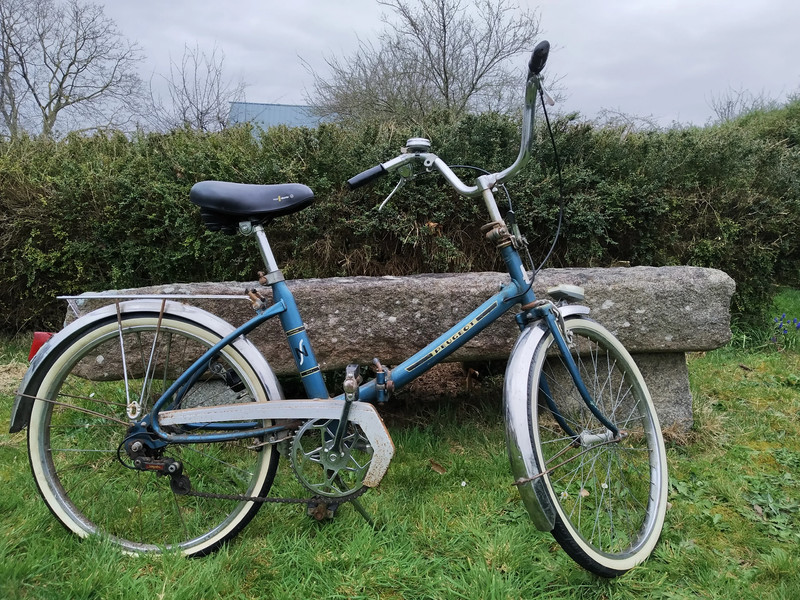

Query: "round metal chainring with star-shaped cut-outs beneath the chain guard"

xmin=289 ymin=419 xmax=374 ymax=498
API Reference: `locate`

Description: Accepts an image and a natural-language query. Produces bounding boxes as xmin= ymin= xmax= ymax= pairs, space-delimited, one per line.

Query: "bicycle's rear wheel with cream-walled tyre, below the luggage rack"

xmin=26 ymin=312 xmax=278 ymax=555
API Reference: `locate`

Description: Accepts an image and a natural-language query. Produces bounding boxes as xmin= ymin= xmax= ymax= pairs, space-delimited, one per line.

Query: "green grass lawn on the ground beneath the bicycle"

xmin=0 ymin=292 xmax=800 ymax=600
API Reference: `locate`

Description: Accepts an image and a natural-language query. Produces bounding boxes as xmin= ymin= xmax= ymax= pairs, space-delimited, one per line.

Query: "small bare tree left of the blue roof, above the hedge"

xmin=150 ymin=45 xmax=245 ymax=131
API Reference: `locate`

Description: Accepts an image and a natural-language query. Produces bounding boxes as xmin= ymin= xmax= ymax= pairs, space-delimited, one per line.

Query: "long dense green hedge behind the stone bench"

xmin=0 ymin=102 xmax=800 ymax=333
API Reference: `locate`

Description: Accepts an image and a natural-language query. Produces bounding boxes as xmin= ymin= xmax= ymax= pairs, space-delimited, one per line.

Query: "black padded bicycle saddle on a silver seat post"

xmin=189 ymin=181 xmax=314 ymax=234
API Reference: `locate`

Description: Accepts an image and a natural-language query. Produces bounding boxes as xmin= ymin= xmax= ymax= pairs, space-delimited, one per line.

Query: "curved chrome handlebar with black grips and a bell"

xmin=347 ymin=41 xmax=550 ymax=202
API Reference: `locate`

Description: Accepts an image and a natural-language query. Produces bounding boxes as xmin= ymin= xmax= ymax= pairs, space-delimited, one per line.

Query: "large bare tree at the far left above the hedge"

xmin=0 ymin=0 xmax=142 ymax=136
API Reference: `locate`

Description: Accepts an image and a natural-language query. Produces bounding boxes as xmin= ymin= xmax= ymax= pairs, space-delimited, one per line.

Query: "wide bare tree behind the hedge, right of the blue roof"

xmin=309 ymin=0 xmax=539 ymax=121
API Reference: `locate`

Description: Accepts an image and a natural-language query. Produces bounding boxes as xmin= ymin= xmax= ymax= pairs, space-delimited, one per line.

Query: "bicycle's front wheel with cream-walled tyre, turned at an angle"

xmin=528 ymin=318 xmax=667 ymax=577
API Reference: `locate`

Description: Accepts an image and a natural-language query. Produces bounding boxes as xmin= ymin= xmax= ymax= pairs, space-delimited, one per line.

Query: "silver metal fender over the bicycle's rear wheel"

xmin=9 ymin=300 xmax=283 ymax=433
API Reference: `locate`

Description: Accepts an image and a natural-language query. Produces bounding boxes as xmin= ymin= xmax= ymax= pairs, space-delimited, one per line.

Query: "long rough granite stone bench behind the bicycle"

xmin=68 ymin=267 xmax=735 ymax=430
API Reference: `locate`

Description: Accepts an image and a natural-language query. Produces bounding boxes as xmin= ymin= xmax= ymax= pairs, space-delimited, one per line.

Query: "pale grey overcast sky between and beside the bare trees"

xmin=100 ymin=0 xmax=800 ymax=125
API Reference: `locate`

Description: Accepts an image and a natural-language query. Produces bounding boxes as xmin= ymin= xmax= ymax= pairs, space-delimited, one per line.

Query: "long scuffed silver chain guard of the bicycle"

xmin=158 ymin=400 xmax=394 ymax=487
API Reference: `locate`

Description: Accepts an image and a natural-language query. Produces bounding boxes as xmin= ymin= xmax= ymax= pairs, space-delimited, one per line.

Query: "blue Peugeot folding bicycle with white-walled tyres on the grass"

xmin=11 ymin=42 xmax=667 ymax=577
